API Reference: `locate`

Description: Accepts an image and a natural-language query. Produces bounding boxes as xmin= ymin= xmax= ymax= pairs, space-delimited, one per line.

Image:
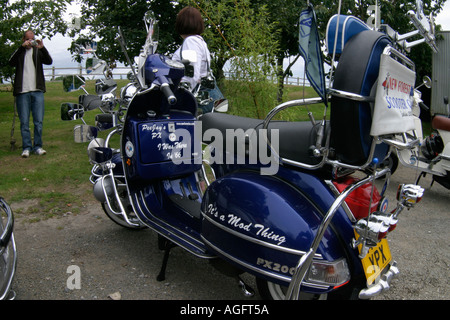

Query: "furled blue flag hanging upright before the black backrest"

xmin=299 ymin=5 xmax=327 ymax=104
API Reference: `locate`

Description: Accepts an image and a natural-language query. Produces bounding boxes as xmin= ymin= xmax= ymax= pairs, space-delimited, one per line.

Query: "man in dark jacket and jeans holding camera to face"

xmin=9 ymin=30 xmax=53 ymax=158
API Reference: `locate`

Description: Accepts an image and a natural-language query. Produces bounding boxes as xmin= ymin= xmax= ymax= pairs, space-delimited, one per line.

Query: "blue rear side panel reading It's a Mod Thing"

xmin=202 ymin=172 xmax=344 ymax=289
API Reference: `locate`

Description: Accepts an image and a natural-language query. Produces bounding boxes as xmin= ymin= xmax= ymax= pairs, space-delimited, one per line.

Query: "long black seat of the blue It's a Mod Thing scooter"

xmin=200 ymin=112 xmax=321 ymax=165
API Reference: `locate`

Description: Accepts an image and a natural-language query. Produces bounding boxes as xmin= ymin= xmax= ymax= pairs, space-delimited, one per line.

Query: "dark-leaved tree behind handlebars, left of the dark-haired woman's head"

xmin=70 ymin=0 xmax=181 ymax=62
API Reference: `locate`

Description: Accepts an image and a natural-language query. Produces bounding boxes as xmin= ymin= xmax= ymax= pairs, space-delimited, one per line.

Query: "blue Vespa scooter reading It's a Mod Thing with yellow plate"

xmin=63 ymin=3 xmax=432 ymax=299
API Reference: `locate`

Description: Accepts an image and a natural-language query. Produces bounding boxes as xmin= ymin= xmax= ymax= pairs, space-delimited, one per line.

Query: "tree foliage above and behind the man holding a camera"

xmin=0 ymin=0 xmax=70 ymax=81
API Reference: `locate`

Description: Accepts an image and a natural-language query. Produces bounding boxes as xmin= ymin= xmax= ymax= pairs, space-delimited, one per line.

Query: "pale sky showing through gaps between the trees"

xmin=44 ymin=1 xmax=450 ymax=77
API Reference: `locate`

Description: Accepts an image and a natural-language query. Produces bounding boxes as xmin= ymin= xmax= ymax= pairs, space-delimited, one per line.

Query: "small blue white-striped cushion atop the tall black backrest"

xmin=325 ymin=14 xmax=370 ymax=55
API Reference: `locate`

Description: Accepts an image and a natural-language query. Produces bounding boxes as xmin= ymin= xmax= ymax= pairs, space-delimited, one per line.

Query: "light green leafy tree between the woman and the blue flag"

xmin=181 ymin=0 xmax=279 ymax=118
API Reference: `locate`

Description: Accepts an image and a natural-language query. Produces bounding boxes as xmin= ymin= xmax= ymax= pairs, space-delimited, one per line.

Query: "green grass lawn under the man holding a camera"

xmin=0 ymin=81 xmax=130 ymax=216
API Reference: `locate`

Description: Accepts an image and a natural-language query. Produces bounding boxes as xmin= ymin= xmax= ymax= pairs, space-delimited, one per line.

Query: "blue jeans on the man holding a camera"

xmin=16 ymin=91 xmax=44 ymax=151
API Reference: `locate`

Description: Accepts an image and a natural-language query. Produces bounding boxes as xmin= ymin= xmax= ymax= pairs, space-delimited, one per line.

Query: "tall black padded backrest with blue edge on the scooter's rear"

xmin=330 ymin=30 xmax=390 ymax=165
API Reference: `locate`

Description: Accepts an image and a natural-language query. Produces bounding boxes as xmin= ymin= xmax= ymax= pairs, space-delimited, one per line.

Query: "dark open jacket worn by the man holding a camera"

xmin=9 ymin=46 xmax=53 ymax=96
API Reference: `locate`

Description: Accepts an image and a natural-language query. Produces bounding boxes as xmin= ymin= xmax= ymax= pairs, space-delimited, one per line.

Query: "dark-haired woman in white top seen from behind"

xmin=172 ymin=7 xmax=229 ymax=113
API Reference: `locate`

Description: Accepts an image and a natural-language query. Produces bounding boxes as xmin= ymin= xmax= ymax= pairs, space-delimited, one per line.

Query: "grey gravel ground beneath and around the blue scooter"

xmin=10 ymin=168 xmax=450 ymax=300
